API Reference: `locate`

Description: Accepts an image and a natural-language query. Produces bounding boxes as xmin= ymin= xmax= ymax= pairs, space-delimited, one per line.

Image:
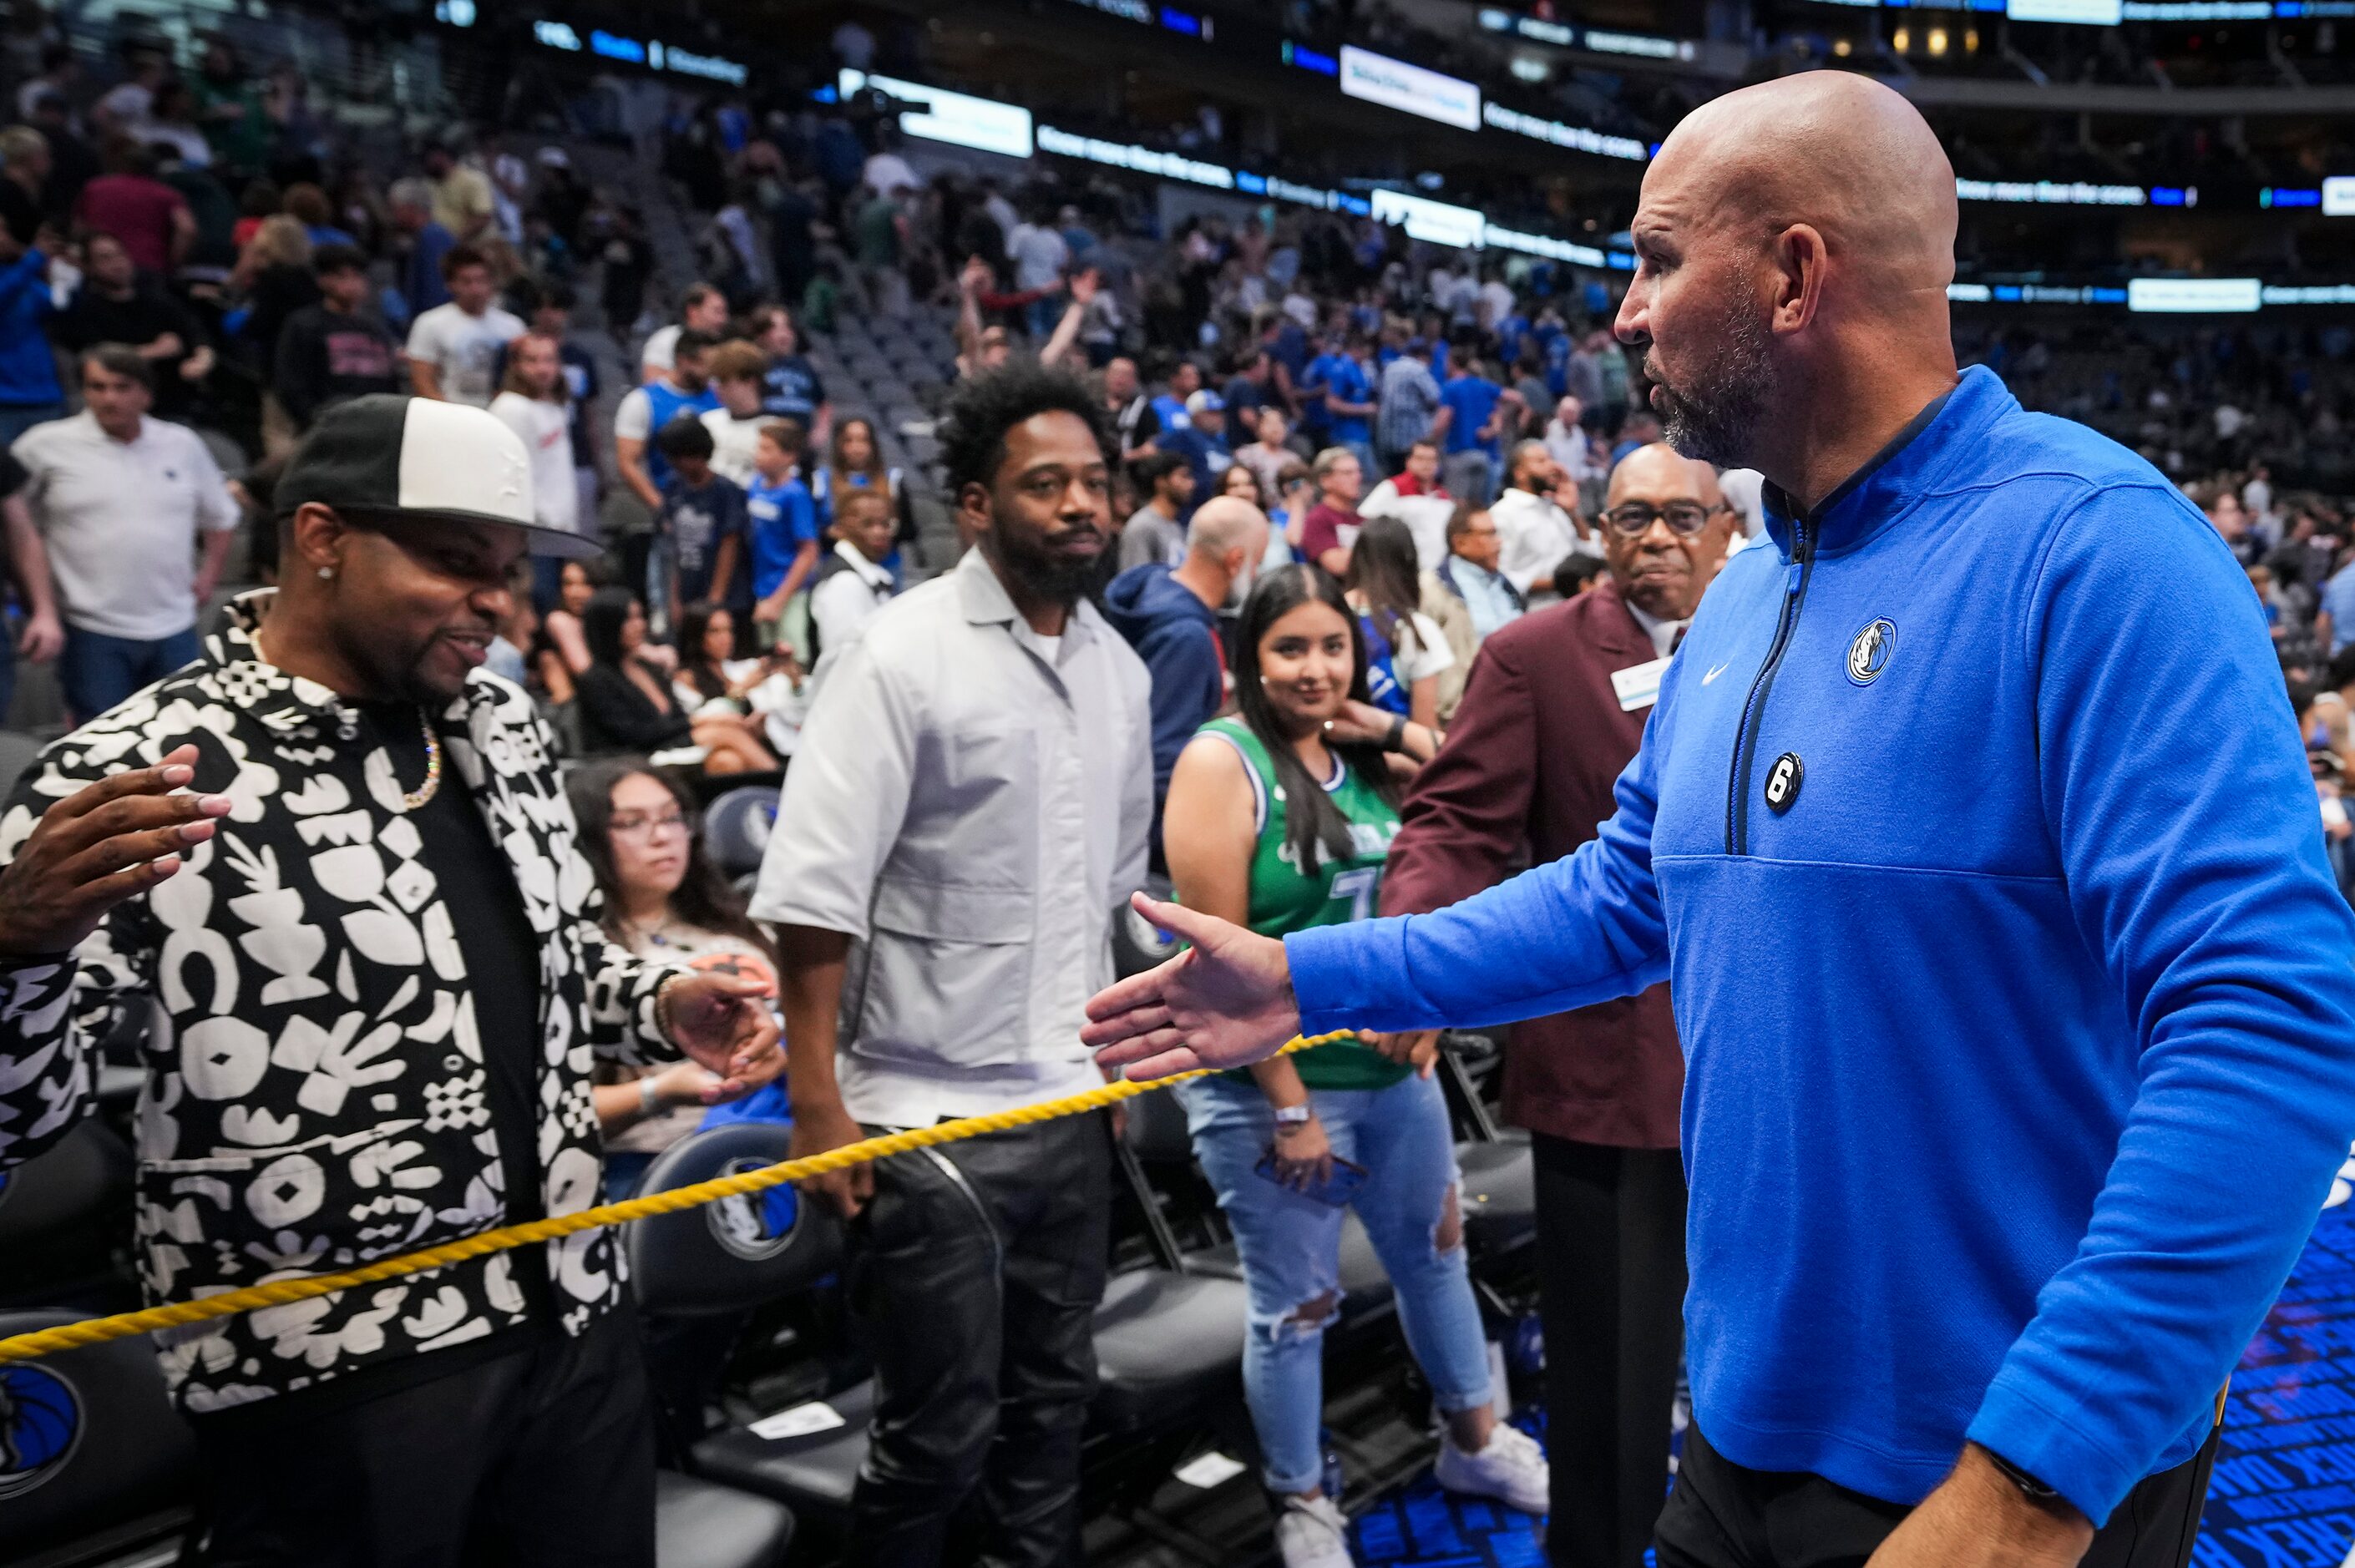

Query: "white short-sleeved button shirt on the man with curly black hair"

xmin=752 ymin=549 xmax=1154 ymax=1128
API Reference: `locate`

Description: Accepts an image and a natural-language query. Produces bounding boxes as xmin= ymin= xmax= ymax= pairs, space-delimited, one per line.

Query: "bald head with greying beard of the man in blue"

xmin=1618 ymin=71 xmax=1955 ymax=494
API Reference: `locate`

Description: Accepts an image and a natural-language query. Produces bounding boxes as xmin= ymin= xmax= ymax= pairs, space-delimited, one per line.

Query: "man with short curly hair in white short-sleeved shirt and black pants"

xmin=752 ymin=362 xmax=1154 ymax=1565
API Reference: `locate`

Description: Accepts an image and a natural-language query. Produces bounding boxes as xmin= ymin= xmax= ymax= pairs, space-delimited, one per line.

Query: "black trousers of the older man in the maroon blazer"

xmin=1528 ymin=1132 xmax=1684 ymax=1568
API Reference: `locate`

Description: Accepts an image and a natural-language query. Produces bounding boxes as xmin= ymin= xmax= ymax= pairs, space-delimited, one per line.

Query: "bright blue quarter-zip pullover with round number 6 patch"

xmin=1286 ymin=370 xmax=2355 ymax=1523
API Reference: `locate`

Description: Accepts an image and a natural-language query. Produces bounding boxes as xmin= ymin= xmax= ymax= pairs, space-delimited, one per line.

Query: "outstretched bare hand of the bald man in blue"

xmin=1079 ymin=893 xmax=1300 ymax=1078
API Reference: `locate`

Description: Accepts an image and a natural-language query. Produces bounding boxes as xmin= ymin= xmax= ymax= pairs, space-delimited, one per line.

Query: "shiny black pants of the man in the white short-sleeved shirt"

xmin=850 ymin=1114 xmax=1112 ymax=1568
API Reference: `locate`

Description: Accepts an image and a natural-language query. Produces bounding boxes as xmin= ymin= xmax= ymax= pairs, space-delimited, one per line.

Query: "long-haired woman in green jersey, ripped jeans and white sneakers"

xmin=1163 ymin=565 xmax=1547 ymax=1568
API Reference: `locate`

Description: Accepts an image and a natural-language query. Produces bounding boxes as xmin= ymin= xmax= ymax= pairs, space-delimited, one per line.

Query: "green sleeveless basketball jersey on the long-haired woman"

xmin=1201 ymin=718 xmax=1410 ymax=1090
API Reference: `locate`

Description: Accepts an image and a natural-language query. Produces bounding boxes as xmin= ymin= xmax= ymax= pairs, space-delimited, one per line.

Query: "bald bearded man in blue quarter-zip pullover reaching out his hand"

xmin=1088 ymin=71 xmax=2355 ymax=1568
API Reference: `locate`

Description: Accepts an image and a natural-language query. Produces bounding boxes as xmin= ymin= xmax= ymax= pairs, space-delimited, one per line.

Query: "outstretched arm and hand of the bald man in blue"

xmin=1081 ymin=669 xmax=1674 ymax=1078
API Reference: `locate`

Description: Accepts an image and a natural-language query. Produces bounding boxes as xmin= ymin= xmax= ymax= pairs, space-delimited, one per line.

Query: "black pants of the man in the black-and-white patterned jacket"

xmin=198 ymin=1312 xmax=655 ymax=1568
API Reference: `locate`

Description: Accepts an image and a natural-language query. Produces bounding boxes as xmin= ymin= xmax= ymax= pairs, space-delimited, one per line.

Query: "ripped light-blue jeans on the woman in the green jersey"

xmin=1172 ymin=1074 xmax=1488 ymax=1493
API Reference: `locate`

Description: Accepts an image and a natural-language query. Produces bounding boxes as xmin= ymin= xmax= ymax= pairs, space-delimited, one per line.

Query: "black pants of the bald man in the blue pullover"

xmin=1660 ymin=1427 xmax=2223 ymax=1568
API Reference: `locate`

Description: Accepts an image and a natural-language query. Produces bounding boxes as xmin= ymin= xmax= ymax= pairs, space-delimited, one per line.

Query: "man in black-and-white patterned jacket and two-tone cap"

xmin=0 ymin=398 xmax=782 ymax=1565
